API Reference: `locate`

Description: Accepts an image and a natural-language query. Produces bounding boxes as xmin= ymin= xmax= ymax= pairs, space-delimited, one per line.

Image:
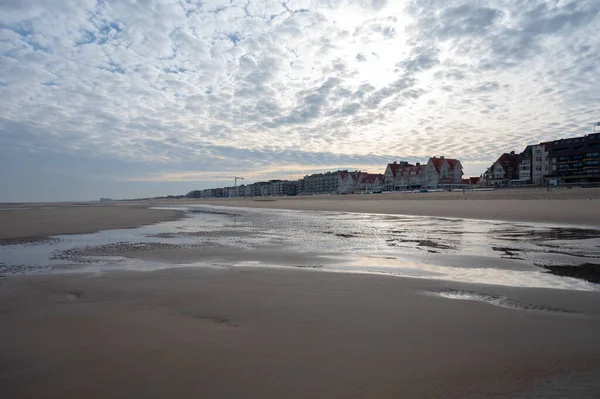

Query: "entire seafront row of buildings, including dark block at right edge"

xmin=187 ymin=133 xmax=600 ymax=198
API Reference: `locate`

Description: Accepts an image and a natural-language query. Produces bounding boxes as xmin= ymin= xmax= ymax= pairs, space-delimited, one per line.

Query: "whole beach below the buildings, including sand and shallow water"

xmin=0 ymin=190 xmax=600 ymax=399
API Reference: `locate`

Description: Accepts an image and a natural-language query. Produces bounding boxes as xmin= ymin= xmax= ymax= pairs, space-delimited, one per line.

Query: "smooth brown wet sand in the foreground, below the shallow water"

xmin=0 ymin=268 xmax=600 ymax=398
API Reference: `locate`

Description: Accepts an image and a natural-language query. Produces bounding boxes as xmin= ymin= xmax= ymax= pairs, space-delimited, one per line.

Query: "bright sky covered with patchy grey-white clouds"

xmin=0 ymin=0 xmax=600 ymax=202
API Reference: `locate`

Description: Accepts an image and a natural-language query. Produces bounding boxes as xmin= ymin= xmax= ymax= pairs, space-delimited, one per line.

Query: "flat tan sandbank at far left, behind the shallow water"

xmin=0 ymin=203 xmax=182 ymax=244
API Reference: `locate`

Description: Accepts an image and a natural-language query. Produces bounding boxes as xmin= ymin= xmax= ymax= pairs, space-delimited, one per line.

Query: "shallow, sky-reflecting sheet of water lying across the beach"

xmin=0 ymin=206 xmax=600 ymax=291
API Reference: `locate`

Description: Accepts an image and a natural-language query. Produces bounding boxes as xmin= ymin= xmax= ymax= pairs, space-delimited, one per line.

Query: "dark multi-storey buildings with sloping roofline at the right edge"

xmin=481 ymin=133 xmax=600 ymax=186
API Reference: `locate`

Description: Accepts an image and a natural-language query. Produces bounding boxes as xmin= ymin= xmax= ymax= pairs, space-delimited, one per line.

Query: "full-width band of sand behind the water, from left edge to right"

xmin=0 ymin=189 xmax=600 ymax=245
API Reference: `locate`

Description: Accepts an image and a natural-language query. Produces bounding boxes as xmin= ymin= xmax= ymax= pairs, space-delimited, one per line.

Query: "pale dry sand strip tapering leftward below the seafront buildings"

xmin=153 ymin=189 xmax=600 ymax=226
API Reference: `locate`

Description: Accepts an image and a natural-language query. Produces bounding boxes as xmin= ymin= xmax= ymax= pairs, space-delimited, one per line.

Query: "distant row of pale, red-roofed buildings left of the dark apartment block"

xmin=187 ymin=156 xmax=473 ymax=198
